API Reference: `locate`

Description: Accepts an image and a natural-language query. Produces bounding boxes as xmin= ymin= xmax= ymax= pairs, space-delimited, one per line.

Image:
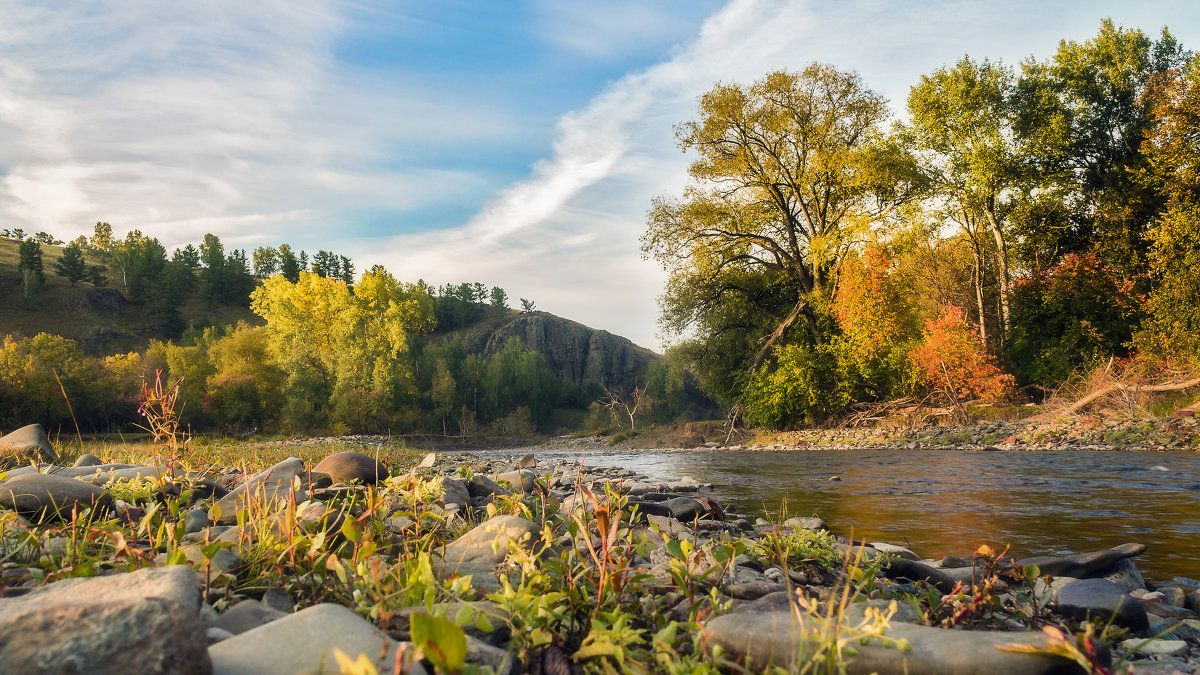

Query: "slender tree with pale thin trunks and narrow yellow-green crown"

xmin=908 ymin=56 xmax=1026 ymax=345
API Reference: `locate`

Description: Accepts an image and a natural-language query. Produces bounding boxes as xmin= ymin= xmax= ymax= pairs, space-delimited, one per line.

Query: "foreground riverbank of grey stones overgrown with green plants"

xmin=0 ymin=428 xmax=1200 ymax=674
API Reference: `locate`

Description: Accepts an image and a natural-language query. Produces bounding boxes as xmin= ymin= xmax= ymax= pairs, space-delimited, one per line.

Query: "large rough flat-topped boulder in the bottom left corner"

xmin=0 ymin=566 xmax=211 ymax=675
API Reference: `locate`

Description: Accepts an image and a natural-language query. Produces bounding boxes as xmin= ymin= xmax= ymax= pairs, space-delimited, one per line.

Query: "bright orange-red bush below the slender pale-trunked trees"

xmin=908 ymin=304 xmax=1013 ymax=401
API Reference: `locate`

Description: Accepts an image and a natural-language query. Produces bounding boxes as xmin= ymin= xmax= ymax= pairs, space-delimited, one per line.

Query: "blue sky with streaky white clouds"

xmin=0 ymin=0 xmax=1200 ymax=350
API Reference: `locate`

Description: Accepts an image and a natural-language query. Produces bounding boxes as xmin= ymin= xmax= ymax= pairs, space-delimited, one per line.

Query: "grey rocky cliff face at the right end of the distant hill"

xmin=466 ymin=312 xmax=659 ymax=392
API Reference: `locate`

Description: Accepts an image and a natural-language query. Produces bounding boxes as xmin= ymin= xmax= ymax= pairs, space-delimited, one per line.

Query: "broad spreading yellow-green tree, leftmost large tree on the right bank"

xmin=642 ymin=64 xmax=920 ymax=371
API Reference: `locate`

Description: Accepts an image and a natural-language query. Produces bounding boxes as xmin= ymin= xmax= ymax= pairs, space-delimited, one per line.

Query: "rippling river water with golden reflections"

xmin=482 ymin=449 xmax=1200 ymax=583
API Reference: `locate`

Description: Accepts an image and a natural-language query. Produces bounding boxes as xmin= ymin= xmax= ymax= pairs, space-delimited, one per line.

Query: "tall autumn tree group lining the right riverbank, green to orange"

xmin=642 ymin=20 xmax=1200 ymax=426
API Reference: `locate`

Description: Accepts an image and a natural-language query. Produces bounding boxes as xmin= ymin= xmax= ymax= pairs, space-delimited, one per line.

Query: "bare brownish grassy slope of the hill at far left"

xmin=0 ymin=239 xmax=262 ymax=356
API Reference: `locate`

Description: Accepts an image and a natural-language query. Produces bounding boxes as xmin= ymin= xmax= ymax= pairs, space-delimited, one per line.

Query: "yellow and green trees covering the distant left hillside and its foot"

xmin=0 ymin=222 xmax=688 ymax=436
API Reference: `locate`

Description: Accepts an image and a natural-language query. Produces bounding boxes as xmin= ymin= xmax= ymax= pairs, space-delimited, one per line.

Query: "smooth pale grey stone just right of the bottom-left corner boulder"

xmin=209 ymin=603 xmax=424 ymax=675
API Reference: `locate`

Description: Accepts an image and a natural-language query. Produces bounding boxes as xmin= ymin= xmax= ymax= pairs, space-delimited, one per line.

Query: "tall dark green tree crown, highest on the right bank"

xmin=1018 ymin=19 xmax=1192 ymax=275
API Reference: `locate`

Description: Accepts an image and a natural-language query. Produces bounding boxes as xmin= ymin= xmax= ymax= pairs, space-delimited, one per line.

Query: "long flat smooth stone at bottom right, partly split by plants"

xmin=703 ymin=611 xmax=1104 ymax=675
